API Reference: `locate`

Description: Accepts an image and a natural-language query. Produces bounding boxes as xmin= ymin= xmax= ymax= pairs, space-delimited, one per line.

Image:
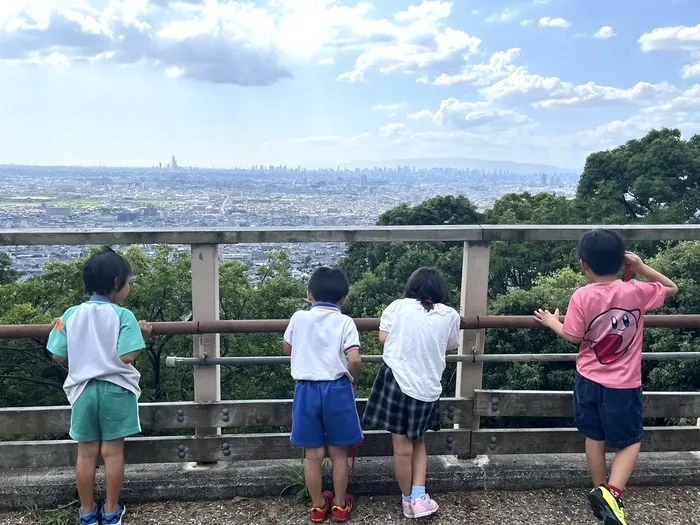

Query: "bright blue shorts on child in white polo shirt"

xmin=291 ymin=376 xmax=362 ymax=448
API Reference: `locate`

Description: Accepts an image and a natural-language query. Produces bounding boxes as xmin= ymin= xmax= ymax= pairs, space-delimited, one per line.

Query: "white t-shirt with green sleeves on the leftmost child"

xmin=46 ymin=296 xmax=146 ymax=406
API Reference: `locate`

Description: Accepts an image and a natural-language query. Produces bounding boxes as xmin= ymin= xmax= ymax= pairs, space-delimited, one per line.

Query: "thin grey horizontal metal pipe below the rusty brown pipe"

xmin=165 ymin=352 xmax=700 ymax=368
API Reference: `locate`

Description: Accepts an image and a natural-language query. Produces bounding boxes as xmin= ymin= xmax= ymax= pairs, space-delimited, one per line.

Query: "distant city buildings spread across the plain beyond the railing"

xmin=0 ymin=164 xmax=578 ymax=276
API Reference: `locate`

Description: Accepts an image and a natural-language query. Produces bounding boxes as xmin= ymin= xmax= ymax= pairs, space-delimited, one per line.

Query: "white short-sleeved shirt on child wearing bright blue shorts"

xmin=284 ymin=303 xmax=360 ymax=381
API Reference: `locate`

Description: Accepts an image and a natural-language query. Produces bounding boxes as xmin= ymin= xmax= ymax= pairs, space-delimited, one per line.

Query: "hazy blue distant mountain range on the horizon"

xmin=341 ymin=157 xmax=581 ymax=174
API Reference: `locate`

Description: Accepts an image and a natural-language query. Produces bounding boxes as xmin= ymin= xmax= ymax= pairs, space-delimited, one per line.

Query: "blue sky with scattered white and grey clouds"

xmin=0 ymin=0 xmax=700 ymax=168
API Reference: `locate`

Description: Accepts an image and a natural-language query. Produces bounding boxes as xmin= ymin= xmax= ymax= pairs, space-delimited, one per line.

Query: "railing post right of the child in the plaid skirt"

xmin=455 ymin=242 xmax=491 ymax=430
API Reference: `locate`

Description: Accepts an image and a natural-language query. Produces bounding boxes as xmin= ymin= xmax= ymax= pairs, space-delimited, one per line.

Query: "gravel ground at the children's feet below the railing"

xmin=0 ymin=487 xmax=700 ymax=525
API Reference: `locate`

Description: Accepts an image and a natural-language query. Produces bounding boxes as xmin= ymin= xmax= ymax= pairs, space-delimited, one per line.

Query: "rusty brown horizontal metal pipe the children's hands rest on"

xmin=0 ymin=315 xmax=700 ymax=339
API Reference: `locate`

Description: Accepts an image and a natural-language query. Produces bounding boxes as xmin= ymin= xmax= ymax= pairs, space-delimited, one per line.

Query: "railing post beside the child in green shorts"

xmin=192 ymin=244 xmax=221 ymax=446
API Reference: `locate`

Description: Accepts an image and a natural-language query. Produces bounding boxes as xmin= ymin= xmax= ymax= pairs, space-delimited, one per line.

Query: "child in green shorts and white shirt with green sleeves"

xmin=47 ymin=249 xmax=153 ymax=525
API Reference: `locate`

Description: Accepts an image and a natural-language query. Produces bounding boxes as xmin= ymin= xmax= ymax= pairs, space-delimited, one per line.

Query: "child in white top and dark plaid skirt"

xmin=363 ymin=268 xmax=461 ymax=518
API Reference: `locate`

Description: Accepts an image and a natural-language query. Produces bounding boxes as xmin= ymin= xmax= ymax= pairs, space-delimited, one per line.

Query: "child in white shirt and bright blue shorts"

xmin=284 ymin=267 xmax=363 ymax=523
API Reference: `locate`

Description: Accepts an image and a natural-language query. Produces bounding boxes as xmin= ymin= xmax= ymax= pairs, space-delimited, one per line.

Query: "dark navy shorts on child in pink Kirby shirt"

xmin=574 ymin=372 xmax=644 ymax=449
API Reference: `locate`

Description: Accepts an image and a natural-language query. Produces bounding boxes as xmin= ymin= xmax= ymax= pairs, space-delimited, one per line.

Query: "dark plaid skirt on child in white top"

xmin=362 ymin=364 xmax=440 ymax=441
